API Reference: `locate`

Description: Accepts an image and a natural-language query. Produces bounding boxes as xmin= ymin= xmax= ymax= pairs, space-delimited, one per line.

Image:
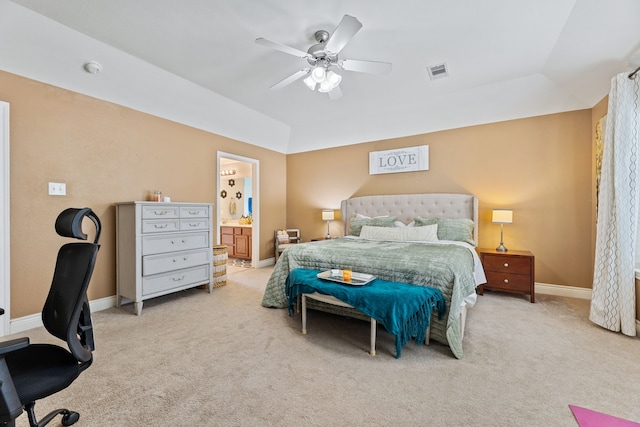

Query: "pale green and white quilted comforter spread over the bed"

xmin=262 ymin=238 xmax=479 ymax=359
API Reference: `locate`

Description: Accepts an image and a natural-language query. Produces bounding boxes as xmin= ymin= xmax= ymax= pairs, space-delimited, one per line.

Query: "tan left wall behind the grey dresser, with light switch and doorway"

xmin=0 ymin=72 xmax=286 ymax=318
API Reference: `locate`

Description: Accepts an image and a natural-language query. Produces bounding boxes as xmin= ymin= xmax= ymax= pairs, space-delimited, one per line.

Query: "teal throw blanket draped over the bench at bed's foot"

xmin=285 ymin=268 xmax=447 ymax=358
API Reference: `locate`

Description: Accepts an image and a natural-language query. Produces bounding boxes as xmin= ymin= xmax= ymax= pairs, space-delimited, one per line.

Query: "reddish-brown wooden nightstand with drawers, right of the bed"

xmin=478 ymin=249 xmax=536 ymax=303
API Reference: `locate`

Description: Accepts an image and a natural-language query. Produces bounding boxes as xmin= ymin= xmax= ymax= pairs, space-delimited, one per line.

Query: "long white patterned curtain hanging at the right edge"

xmin=589 ymin=73 xmax=640 ymax=336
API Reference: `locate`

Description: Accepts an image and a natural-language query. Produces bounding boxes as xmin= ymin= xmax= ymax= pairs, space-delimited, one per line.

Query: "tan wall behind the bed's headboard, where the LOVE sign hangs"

xmin=287 ymin=110 xmax=593 ymax=288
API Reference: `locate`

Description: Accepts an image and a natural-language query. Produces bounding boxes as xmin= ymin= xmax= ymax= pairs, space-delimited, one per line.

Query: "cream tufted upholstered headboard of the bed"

xmin=340 ymin=193 xmax=478 ymax=242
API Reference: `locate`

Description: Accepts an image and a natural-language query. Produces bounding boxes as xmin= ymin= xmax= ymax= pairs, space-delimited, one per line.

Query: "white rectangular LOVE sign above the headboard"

xmin=369 ymin=145 xmax=429 ymax=175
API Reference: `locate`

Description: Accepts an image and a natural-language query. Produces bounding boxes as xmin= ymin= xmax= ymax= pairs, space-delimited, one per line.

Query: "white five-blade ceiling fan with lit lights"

xmin=256 ymin=15 xmax=391 ymax=100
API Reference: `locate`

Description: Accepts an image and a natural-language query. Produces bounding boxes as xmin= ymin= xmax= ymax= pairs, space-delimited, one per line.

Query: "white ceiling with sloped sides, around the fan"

xmin=0 ymin=0 xmax=640 ymax=153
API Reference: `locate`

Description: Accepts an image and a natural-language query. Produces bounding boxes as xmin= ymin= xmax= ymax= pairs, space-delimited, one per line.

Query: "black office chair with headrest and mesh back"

xmin=0 ymin=208 xmax=101 ymax=427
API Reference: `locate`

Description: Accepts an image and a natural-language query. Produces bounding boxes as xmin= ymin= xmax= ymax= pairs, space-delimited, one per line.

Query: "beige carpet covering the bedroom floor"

xmin=7 ymin=268 xmax=640 ymax=427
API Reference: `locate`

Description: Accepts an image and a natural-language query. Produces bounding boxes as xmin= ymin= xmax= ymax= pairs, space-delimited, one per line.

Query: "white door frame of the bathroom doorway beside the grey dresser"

xmin=215 ymin=151 xmax=260 ymax=268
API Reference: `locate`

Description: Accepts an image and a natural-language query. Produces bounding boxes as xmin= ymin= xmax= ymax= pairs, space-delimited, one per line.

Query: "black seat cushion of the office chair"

xmin=5 ymin=344 xmax=81 ymax=405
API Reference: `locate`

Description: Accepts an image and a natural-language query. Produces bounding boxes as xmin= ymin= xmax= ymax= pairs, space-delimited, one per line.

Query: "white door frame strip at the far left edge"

xmin=0 ymin=101 xmax=11 ymax=336
